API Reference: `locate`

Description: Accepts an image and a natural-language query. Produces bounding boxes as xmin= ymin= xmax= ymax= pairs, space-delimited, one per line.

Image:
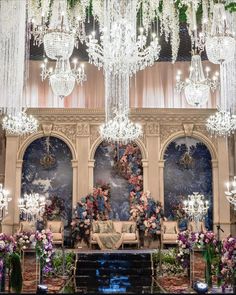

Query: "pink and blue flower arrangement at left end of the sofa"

xmin=71 ymin=184 xmax=110 ymax=244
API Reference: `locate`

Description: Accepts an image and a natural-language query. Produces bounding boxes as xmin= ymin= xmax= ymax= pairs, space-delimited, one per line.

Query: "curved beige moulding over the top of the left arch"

xmin=17 ymin=131 xmax=77 ymax=161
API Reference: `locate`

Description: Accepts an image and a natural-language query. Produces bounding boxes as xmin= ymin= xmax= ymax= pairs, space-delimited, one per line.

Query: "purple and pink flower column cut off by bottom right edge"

xmin=221 ymin=236 xmax=236 ymax=286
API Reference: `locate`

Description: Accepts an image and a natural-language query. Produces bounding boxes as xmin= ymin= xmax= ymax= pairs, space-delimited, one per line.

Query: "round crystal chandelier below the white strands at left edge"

xmin=2 ymin=110 xmax=38 ymax=136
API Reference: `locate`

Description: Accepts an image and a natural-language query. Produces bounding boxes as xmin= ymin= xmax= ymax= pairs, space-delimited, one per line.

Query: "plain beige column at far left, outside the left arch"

xmin=3 ymin=135 xmax=19 ymax=234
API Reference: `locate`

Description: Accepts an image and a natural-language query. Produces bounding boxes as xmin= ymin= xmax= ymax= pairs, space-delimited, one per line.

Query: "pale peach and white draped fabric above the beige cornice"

xmin=26 ymin=61 xmax=219 ymax=108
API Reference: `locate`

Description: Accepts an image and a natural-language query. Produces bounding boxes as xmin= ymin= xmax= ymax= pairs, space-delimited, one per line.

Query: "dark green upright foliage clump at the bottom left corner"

xmin=10 ymin=253 xmax=23 ymax=293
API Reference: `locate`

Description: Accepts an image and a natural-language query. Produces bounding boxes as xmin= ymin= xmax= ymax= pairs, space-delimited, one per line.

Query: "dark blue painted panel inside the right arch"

xmin=164 ymin=137 xmax=213 ymax=229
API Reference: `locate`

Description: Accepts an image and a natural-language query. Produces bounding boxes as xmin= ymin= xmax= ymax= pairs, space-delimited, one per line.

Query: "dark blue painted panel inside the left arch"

xmin=21 ymin=137 xmax=72 ymax=226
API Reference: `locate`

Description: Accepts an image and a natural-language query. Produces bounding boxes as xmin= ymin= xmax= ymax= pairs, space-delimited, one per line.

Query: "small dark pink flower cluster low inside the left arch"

xmin=43 ymin=196 xmax=65 ymax=220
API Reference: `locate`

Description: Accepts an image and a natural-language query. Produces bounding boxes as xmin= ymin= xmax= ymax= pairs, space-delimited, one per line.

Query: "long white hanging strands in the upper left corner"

xmin=0 ymin=0 xmax=26 ymax=115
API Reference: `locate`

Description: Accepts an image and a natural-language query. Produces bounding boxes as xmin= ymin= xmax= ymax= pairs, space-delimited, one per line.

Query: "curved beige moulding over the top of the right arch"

xmin=159 ymin=131 xmax=217 ymax=161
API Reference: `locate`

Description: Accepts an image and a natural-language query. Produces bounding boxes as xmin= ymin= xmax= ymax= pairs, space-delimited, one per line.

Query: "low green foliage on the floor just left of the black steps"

xmin=52 ymin=250 xmax=75 ymax=276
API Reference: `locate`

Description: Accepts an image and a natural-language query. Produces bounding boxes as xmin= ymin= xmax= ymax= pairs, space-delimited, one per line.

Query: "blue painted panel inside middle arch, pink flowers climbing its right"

xmin=94 ymin=142 xmax=143 ymax=220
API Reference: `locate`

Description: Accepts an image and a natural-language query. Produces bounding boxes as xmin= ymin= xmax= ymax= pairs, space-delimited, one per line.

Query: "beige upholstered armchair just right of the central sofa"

xmin=161 ymin=221 xmax=179 ymax=246
